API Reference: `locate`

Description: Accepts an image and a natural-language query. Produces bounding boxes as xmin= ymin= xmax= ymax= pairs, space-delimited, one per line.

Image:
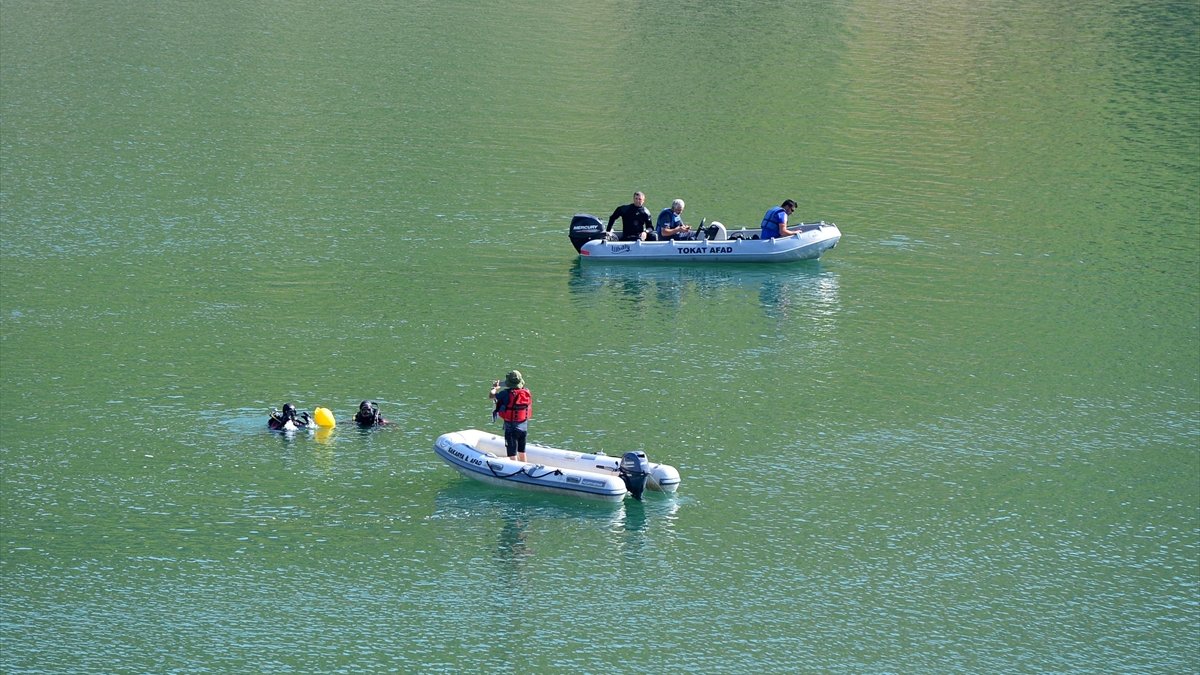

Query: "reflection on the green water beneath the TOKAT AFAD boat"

xmin=568 ymin=259 xmax=839 ymax=318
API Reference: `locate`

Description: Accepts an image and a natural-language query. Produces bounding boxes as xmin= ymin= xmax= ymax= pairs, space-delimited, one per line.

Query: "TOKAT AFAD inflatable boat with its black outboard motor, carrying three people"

xmin=570 ymin=214 xmax=841 ymax=263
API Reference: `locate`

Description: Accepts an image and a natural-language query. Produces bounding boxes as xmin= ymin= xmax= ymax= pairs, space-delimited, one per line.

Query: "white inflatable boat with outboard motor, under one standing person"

xmin=433 ymin=429 xmax=679 ymax=502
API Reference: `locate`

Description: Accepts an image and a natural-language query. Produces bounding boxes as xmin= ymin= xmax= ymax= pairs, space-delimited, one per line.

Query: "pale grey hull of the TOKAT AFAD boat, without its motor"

xmin=580 ymin=222 xmax=841 ymax=263
